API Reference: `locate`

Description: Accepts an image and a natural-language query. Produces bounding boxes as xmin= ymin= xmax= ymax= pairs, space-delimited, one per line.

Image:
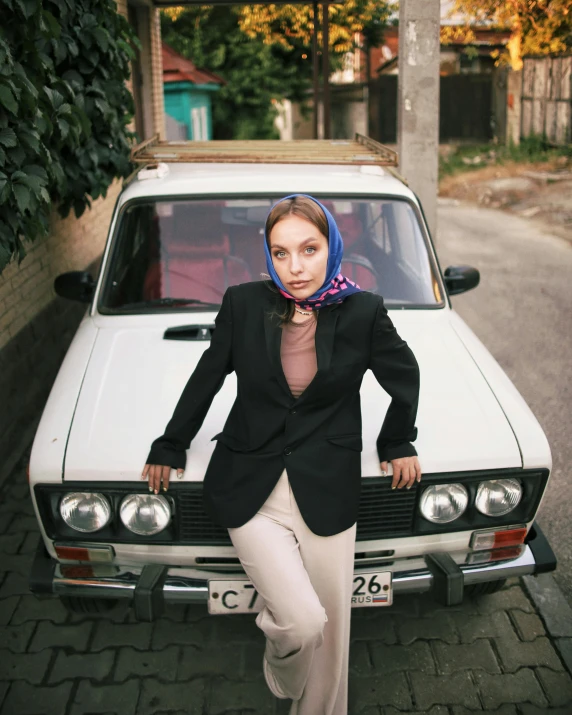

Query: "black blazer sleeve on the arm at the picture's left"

xmin=146 ymin=288 xmax=233 ymax=469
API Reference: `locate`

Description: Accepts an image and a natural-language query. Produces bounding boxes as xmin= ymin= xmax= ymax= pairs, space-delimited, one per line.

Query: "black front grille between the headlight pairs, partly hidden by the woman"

xmin=176 ymin=477 xmax=417 ymax=546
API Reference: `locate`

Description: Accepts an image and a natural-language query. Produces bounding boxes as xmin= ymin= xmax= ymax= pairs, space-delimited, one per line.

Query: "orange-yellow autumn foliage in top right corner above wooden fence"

xmin=441 ymin=0 xmax=572 ymax=69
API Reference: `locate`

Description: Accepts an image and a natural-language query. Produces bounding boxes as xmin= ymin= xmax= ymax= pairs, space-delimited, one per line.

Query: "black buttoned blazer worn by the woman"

xmin=147 ymin=281 xmax=419 ymax=536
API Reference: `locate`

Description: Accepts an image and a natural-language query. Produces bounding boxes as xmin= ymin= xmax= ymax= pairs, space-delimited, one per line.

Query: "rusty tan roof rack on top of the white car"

xmin=131 ymin=134 xmax=397 ymax=167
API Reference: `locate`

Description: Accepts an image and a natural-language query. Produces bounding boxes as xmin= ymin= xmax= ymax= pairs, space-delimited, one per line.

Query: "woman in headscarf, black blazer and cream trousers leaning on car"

xmin=143 ymin=194 xmax=421 ymax=715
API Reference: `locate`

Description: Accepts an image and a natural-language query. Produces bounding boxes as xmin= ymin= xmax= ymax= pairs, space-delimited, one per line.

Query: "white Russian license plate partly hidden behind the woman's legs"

xmin=208 ymin=571 xmax=393 ymax=615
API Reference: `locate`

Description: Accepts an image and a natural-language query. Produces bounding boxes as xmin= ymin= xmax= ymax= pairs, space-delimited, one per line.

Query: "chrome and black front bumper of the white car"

xmin=30 ymin=523 xmax=556 ymax=621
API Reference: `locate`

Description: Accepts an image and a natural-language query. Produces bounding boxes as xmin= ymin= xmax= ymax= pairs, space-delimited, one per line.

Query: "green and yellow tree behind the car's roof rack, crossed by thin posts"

xmin=161 ymin=0 xmax=389 ymax=139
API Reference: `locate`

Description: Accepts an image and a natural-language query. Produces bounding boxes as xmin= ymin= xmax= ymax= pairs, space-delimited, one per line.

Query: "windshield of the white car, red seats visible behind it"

xmin=98 ymin=196 xmax=443 ymax=313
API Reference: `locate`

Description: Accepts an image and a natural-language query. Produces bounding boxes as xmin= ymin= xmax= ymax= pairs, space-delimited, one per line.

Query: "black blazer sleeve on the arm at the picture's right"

xmin=369 ymin=296 xmax=420 ymax=462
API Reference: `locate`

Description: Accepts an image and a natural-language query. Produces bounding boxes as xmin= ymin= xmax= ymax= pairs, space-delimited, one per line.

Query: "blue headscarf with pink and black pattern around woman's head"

xmin=264 ymin=194 xmax=362 ymax=310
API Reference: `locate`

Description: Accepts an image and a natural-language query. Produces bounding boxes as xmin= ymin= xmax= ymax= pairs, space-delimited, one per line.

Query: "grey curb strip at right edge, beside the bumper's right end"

xmin=522 ymin=573 xmax=572 ymax=674
